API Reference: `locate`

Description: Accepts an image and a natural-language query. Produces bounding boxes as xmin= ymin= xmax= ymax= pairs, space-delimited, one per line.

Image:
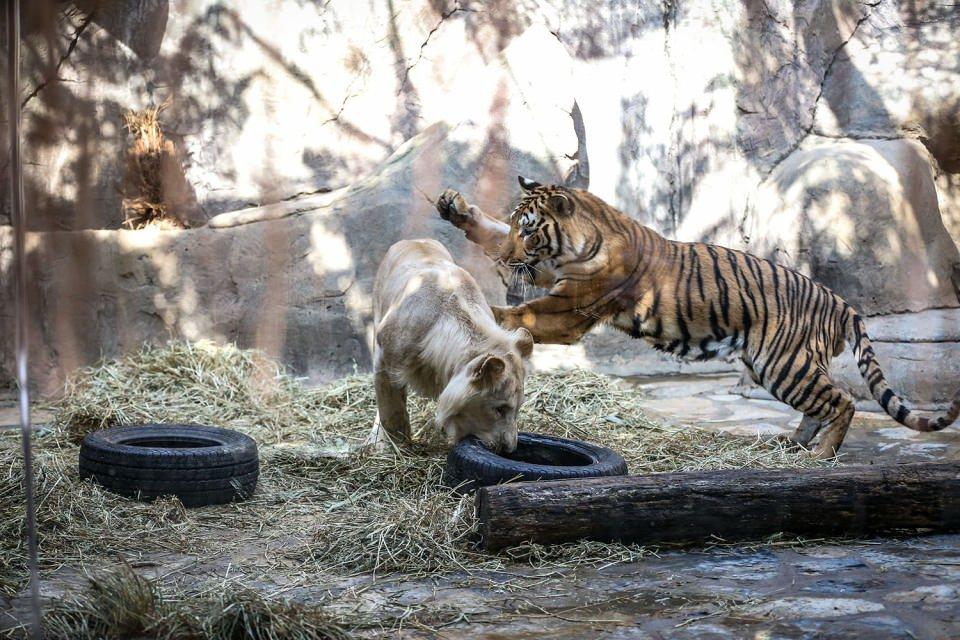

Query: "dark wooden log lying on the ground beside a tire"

xmin=476 ymin=463 xmax=960 ymax=550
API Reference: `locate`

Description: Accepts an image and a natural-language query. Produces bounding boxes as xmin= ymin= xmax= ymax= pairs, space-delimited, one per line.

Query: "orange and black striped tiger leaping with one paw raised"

xmin=437 ymin=178 xmax=960 ymax=457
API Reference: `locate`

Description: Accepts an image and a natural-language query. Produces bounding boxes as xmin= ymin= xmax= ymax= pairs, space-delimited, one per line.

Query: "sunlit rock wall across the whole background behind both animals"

xmin=0 ymin=0 xmax=960 ymax=404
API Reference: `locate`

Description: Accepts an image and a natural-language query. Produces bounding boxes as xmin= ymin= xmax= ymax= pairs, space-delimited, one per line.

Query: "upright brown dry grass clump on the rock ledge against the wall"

xmin=122 ymin=103 xmax=196 ymax=234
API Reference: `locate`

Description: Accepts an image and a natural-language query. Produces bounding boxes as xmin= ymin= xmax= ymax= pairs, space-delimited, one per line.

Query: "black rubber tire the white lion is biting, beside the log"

xmin=443 ymin=432 xmax=627 ymax=492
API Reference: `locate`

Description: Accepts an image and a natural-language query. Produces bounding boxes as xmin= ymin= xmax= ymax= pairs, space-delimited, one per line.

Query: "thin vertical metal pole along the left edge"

xmin=7 ymin=0 xmax=41 ymax=639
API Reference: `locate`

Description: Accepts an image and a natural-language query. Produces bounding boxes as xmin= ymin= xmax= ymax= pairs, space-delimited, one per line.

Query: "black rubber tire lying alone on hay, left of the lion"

xmin=80 ymin=424 xmax=260 ymax=507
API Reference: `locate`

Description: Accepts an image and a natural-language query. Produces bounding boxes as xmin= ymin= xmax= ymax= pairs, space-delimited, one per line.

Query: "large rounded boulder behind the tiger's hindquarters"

xmin=743 ymin=137 xmax=960 ymax=315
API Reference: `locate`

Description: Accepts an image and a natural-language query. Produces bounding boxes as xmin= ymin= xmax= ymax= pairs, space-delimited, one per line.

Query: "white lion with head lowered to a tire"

xmin=371 ymin=240 xmax=533 ymax=452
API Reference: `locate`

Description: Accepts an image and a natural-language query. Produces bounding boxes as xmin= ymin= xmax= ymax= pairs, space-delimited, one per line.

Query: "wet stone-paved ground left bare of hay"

xmin=0 ymin=375 xmax=960 ymax=640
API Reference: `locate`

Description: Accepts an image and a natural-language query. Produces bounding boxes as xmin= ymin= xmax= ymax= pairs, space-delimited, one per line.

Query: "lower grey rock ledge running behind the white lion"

xmin=0 ymin=117 xmax=564 ymax=394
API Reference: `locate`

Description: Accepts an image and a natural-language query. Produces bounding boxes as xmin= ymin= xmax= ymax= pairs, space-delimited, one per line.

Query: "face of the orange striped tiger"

xmin=500 ymin=177 xmax=599 ymax=282
